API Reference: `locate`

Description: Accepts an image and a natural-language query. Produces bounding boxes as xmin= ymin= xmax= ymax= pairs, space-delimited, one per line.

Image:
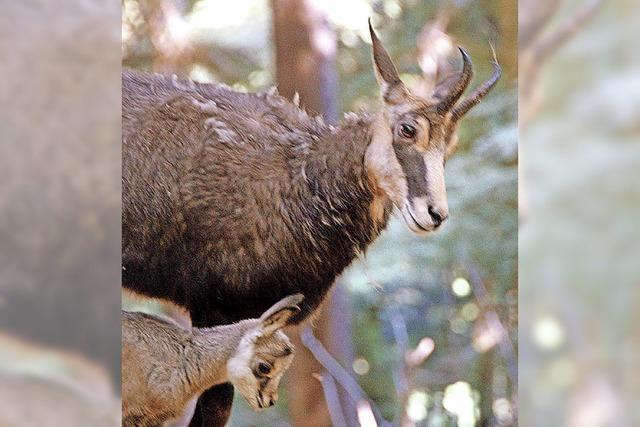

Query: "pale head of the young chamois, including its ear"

xmin=227 ymin=294 xmax=304 ymax=411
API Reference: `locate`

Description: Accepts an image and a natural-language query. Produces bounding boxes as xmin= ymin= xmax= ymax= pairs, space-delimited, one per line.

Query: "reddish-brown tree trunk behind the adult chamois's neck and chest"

xmin=272 ymin=0 xmax=357 ymax=427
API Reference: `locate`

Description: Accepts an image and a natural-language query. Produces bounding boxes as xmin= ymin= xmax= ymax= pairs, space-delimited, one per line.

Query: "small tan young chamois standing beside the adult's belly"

xmin=122 ymin=294 xmax=303 ymax=427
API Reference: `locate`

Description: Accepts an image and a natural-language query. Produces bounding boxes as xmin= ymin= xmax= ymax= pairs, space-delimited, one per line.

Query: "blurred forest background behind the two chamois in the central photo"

xmin=122 ymin=0 xmax=518 ymax=427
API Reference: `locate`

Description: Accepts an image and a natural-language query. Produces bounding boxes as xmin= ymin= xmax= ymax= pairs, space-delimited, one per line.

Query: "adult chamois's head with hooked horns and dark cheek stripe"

xmin=365 ymin=22 xmax=501 ymax=233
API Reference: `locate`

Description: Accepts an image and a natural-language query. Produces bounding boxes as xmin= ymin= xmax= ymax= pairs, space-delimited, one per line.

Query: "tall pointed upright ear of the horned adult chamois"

xmin=369 ymin=19 xmax=409 ymax=105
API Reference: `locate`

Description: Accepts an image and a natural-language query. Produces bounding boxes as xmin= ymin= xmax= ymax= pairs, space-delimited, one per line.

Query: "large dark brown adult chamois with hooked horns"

xmin=122 ymin=26 xmax=500 ymax=426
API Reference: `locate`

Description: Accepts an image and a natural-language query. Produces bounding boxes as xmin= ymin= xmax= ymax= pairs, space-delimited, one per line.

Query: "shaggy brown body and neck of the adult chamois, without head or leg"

xmin=122 ymin=71 xmax=391 ymax=326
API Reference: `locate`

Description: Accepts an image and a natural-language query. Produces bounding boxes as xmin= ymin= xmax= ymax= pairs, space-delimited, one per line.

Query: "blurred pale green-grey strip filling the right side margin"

xmin=519 ymin=0 xmax=640 ymax=427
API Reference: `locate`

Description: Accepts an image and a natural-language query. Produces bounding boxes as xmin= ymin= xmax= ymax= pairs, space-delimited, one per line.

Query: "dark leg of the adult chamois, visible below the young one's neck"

xmin=189 ymin=383 xmax=233 ymax=427
